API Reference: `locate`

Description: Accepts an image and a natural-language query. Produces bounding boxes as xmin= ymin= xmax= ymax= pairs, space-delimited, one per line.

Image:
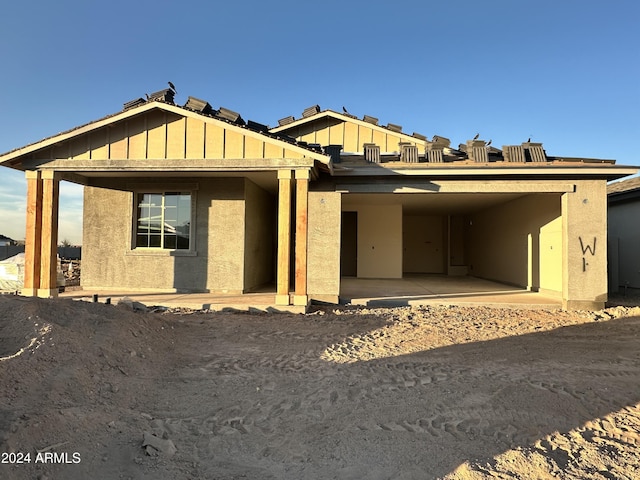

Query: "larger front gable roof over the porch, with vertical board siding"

xmin=0 ymin=97 xmax=332 ymax=170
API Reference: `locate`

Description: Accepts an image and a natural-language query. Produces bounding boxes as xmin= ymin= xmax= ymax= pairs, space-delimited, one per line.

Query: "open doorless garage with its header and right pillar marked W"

xmin=336 ymin=167 xmax=624 ymax=308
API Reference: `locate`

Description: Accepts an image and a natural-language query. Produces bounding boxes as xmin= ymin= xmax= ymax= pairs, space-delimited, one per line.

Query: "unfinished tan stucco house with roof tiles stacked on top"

xmin=0 ymin=90 xmax=637 ymax=309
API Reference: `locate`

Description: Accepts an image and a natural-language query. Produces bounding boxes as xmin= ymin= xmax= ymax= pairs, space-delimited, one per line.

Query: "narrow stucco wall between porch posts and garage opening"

xmin=307 ymin=192 xmax=342 ymax=303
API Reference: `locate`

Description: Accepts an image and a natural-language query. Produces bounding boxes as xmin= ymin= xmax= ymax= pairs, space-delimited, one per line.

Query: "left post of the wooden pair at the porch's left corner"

xmin=22 ymin=170 xmax=42 ymax=297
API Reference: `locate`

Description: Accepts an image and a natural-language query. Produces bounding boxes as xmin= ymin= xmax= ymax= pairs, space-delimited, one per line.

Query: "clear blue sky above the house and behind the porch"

xmin=0 ymin=0 xmax=640 ymax=243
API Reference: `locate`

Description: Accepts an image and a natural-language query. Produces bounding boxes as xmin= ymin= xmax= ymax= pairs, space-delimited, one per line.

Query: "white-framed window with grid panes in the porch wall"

xmin=135 ymin=192 xmax=192 ymax=250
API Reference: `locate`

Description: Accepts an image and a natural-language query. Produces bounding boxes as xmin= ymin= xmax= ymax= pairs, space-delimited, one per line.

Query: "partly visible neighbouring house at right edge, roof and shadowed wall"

xmin=607 ymin=177 xmax=640 ymax=293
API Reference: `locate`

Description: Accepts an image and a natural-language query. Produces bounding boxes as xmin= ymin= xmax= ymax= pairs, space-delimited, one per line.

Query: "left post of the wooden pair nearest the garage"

xmin=276 ymin=170 xmax=291 ymax=305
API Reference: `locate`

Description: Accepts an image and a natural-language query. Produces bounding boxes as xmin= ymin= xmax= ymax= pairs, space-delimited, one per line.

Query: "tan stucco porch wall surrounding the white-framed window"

xmin=82 ymin=178 xmax=274 ymax=293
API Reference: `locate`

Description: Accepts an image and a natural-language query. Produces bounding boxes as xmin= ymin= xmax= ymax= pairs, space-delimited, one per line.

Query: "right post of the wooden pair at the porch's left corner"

xmin=38 ymin=171 xmax=60 ymax=298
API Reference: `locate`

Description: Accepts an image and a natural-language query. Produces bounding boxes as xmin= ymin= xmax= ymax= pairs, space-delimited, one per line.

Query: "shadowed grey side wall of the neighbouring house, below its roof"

xmin=609 ymin=200 xmax=640 ymax=292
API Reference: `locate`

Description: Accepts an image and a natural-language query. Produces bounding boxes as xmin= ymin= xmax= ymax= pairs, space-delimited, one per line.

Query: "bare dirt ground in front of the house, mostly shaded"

xmin=0 ymin=295 xmax=640 ymax=480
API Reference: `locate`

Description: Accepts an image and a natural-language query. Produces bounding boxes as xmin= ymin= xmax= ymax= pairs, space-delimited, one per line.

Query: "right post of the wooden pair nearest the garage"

xmin=293 ymin=170 xmax=309 ymax=305
